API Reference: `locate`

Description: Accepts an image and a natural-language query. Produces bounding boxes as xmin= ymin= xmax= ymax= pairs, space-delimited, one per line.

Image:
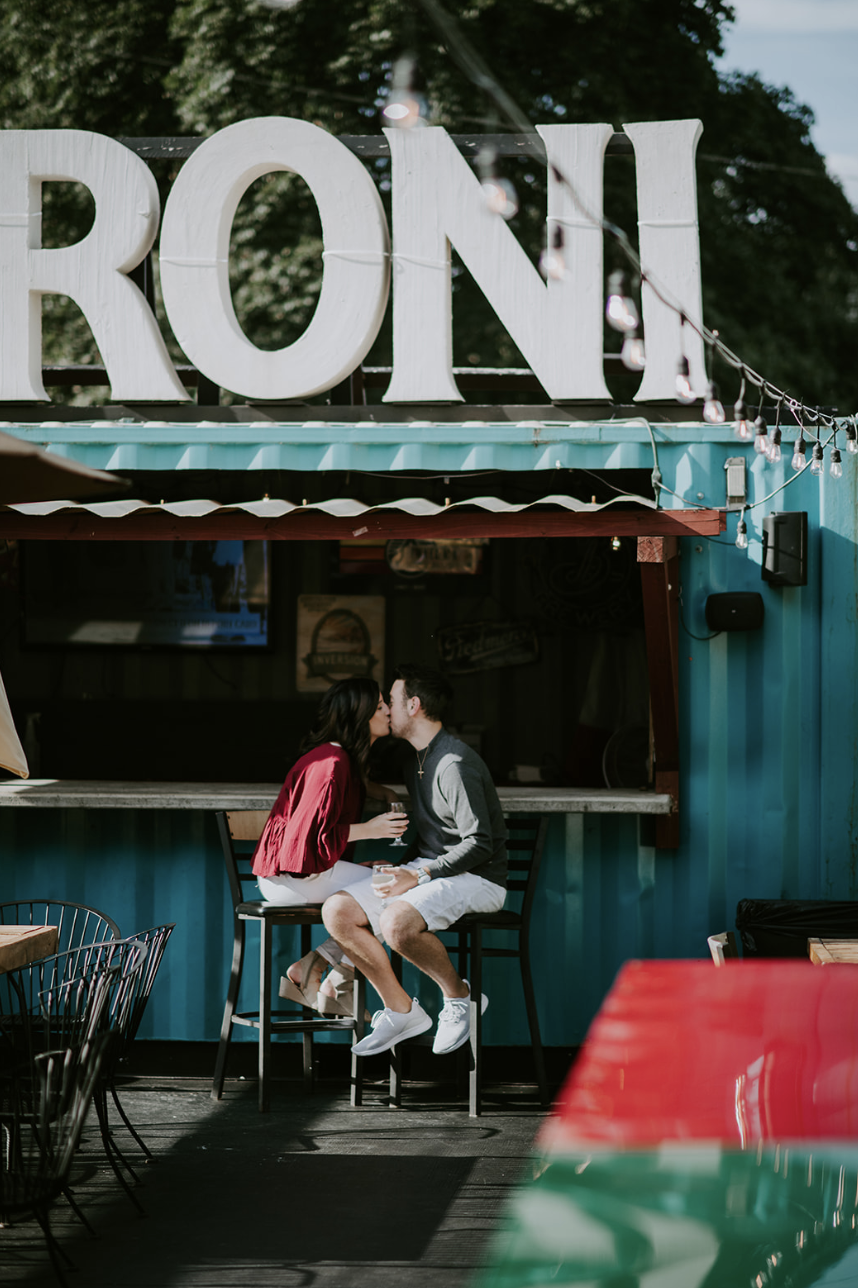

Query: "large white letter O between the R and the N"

xmin=160 ymin=116 xmax=390 ymax=398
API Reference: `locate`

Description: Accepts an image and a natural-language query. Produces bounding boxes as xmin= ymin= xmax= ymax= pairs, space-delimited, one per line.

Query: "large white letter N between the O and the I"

xmin=384 ymin=125 xmax=613 ymax=402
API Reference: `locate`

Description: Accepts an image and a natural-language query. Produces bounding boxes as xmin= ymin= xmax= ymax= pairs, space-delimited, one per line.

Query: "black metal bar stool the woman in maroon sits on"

xmin=211 ymin=810 xmax=366 ymax=1113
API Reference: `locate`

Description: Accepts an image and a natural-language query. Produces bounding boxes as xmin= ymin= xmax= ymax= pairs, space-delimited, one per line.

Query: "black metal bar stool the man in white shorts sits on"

xmin=390 ymin=815 xmax=549 ymax=1117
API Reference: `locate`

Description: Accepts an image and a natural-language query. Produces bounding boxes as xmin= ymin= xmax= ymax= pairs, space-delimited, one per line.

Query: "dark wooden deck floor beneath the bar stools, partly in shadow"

xmin=0 ymin=1077 xmax=544 ymax=1288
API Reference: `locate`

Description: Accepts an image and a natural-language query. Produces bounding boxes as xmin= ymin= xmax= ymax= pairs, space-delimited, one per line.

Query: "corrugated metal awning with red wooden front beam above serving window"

xmin=0 ymin=493 xmax=724 ymax=541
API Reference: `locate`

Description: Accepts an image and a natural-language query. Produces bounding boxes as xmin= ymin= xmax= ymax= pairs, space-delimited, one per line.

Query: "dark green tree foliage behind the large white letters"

xmin=0 ymin=0 xmax=858 ymax=411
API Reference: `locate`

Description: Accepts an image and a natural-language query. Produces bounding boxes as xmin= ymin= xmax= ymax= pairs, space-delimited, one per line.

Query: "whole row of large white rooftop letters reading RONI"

xmin=0 ymin=117 xmax=705 ymax=403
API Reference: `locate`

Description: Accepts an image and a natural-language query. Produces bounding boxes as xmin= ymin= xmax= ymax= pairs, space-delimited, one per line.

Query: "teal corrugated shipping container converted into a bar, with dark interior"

xmin=0 ymin=406 xmax=858 ymax=1047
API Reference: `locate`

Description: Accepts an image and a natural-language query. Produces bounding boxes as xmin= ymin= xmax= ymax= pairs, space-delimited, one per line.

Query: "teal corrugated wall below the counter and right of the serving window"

xmin=0 ymin=426 xmax=858 ymax=1046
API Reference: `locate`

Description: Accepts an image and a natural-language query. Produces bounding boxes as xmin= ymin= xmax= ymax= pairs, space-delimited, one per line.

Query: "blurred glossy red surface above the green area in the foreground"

xmin=539 ymin=960 xmax=858 ymax=1149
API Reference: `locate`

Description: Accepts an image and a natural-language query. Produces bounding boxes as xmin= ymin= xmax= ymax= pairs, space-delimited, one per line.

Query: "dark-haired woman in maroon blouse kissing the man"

xmin=253 ymin=679 xmax=407 ymax=1015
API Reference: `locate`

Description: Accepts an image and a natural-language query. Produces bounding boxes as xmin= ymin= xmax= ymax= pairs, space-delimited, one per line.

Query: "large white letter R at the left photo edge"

xmin=0 ymin=130 xmax=188 ymax=402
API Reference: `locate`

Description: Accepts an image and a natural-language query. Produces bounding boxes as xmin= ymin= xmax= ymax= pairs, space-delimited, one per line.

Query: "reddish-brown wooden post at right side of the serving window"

xmin=638 ymin=537 xmax=679 ymax=850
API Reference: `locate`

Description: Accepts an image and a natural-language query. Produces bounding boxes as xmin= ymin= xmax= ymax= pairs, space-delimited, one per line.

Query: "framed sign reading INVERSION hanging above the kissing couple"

xmin=295 ymin=595 xmax=384 ymax=693
